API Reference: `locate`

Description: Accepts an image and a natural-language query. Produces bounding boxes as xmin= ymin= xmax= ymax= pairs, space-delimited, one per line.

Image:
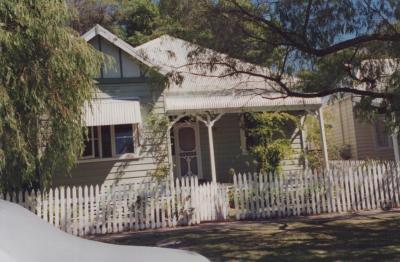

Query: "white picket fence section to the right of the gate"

xmin=232 ymin=163 xmax=400 ymax=220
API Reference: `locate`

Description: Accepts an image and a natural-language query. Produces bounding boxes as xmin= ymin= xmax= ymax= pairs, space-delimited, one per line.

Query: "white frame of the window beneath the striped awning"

xmin=79 ymin=123 xmax=141 ymax=163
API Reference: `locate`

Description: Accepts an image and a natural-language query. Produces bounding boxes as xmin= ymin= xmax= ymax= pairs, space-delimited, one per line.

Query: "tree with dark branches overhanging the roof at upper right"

xmin=157 ymin=0 xmax=400 ymax=126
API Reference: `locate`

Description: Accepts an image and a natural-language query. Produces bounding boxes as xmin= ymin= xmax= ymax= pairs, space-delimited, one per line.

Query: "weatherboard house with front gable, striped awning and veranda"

xmin=55 ymin=25 xmax=328 ymax=185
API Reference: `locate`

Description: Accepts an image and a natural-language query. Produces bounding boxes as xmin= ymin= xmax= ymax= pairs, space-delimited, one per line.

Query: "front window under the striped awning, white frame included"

xmin=82 ymin=124 xmax=140 ymax=160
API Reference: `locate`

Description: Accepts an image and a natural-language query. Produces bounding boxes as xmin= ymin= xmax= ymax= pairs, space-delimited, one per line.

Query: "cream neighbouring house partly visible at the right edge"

xmin=324 ymin=95 xmax=399 ymax=162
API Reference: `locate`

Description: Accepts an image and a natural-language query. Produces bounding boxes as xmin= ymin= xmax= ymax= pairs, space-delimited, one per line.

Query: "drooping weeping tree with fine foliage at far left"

xmin=0 ymin=0 xmax=102 ymax=190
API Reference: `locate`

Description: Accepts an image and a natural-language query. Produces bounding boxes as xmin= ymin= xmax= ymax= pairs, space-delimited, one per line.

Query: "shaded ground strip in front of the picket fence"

xmin=91 ymin=211 xmax=400 ymax=261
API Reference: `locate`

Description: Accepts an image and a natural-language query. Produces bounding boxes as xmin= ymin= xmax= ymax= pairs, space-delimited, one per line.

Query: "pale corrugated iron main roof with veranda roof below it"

xmin=135 ymin=35 xmax=321 ymax=113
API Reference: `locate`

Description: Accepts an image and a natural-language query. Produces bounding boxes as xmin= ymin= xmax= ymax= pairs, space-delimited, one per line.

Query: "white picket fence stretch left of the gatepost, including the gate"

xmin=0 ymin=177 xmax=229 ymax=236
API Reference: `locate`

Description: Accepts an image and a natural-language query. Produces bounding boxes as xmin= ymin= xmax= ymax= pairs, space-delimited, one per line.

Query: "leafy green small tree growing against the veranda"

xmin=245 ymin=112 xmax=298 ymax=172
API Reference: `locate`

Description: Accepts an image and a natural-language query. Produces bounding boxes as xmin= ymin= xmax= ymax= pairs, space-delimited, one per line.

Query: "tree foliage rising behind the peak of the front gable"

xmin=67 ymin=0 xmax=165 ymax=46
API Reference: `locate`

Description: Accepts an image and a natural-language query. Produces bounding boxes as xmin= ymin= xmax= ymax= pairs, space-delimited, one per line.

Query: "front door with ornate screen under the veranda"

xmin=174 ymin=123 xmax=203 ymax=178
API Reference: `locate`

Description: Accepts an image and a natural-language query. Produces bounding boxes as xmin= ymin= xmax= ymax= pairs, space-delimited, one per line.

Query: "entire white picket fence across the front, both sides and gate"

xmin=0 ymin=162 xmax=400 ymax=236
